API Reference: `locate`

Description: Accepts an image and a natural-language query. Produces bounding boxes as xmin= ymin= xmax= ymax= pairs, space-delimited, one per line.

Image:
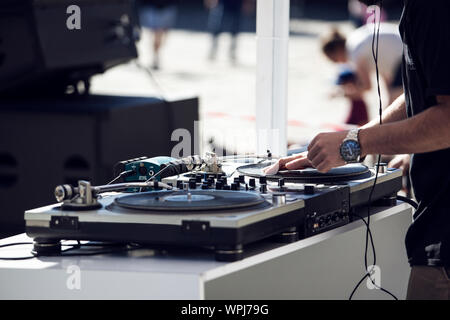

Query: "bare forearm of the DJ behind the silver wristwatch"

xmin=359 ymin=99 xmax=450 ymax=156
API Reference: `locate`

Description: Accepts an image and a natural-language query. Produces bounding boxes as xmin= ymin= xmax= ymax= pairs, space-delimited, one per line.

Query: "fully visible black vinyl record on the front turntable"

xmin=114 ymin=190 xmax=265 ymax=211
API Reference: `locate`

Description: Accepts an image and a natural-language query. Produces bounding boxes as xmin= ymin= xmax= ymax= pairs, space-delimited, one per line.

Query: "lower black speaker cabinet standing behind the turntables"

xmin=0 ymin=96 xmax=198 ymax=235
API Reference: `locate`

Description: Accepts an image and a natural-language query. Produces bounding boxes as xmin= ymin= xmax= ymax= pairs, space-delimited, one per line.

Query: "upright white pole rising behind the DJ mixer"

xmin=256 ymin=0 xmax=289 ymax=156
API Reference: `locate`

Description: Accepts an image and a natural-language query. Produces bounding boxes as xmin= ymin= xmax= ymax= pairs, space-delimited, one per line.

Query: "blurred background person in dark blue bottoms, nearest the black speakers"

xmin=140 ymin=0 xmax=177 ymax=70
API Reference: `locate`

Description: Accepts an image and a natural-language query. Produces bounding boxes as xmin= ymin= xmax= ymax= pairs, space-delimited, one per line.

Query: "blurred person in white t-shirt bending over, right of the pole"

xmin=322 ymin=23 xmax=403 ymax=103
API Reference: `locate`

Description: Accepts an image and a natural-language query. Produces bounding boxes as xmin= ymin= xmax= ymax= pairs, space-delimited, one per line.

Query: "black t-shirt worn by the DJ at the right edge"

xmin=400 ymin=0 xmax=450 ymax=266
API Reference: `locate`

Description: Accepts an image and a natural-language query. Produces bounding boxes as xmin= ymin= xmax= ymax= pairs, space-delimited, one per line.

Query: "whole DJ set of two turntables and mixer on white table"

xmin=25 ymin=158 xmax=402 ymax=261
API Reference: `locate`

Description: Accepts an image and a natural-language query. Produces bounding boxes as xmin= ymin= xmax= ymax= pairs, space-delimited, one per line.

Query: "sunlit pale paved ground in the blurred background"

xmin=92 ymin=12 xmax=398 ymax=156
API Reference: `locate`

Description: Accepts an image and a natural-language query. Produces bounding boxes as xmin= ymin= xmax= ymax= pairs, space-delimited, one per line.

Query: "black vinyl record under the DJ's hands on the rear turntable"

xmin=237 ymin=161 xmax=372 ymax=183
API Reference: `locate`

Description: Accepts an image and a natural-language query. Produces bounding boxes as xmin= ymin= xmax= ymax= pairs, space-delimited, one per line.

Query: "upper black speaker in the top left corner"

xmin=0 ymin=0 xmax=138 ymax=95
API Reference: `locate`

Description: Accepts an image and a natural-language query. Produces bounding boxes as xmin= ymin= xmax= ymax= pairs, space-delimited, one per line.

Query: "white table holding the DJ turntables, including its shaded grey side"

xmin=0 ymin=202 xmax=412 ymax=299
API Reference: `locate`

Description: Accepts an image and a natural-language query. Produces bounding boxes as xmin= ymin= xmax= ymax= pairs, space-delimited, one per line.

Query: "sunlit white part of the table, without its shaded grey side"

xmin=0 ymin=203 xmax=411 ymax=299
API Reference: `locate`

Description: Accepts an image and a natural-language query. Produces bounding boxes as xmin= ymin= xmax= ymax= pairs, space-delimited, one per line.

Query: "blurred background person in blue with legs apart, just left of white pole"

xmin=204 ymin=0 xmax=244 ymax=62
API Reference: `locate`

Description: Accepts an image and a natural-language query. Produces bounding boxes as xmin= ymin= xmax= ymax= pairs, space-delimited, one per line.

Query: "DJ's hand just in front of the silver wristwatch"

xmin=308 ymin=131 xmax=348 ymax=173
